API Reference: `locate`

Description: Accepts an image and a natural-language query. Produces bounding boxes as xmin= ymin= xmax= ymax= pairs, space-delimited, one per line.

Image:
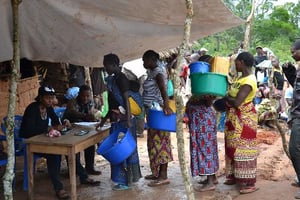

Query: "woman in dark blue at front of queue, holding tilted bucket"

xmin=98 ymin=54 xmax=142 ymax=190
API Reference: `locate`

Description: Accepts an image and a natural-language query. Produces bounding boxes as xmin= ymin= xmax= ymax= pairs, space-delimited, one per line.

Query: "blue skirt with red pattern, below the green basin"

xmin=186 ymin=104 xmax=219 ymax=176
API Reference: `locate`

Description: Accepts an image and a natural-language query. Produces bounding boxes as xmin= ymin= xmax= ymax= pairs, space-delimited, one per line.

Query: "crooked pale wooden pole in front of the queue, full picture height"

xmin=172 ymin=0 xmax=195 ymax=200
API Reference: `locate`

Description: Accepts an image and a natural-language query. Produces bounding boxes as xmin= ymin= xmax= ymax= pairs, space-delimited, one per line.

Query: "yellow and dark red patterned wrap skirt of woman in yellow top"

xmin=224 ymin=102 xmax=258 ymax=185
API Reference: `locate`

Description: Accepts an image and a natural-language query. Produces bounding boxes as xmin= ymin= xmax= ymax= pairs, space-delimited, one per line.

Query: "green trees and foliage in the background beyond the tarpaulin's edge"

xmin=192 ymin=0 xmax=300 ymax=63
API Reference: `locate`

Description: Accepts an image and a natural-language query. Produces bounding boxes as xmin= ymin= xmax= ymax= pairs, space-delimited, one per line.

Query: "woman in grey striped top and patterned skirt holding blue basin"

xmin=143 ymin=50 xmax=173 ymax=187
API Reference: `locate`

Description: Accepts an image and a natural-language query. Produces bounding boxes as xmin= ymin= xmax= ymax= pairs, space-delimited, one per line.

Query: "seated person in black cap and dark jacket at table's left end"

xmin=20 ymin=86 xmax=100 ymax=199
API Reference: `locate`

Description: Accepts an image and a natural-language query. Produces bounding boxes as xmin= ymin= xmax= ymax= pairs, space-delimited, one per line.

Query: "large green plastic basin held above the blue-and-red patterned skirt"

xmin=190 ymin=73 xmax=227 ymax=96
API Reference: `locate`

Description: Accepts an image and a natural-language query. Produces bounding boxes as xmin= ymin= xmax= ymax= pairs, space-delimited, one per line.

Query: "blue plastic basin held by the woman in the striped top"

xmin=147 ymin=109 xmax=176 ymax=132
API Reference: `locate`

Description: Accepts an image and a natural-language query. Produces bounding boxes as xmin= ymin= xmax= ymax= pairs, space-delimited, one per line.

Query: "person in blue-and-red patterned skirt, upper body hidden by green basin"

xmin=186 ymin=95 xmax=219 ymax=192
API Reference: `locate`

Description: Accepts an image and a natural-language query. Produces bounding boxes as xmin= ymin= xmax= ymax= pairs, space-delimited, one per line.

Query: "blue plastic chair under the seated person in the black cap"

xmin=0 ymin=115 xmax=40 ymax=191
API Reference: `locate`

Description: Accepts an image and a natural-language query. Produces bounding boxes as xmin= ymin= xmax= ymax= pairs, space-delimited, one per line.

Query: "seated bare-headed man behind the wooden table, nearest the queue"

xmin=63 ymin=85 xmax=101 ymax=175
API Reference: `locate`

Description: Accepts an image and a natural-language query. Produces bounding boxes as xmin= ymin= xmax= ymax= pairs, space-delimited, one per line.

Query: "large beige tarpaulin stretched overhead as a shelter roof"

xmin=0 ymin=0 xmax=243 ymax=67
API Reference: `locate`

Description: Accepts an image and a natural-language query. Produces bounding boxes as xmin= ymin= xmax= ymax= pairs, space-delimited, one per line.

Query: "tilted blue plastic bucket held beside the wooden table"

xmin=97 ymin=129 xmax=136 ymax=165
